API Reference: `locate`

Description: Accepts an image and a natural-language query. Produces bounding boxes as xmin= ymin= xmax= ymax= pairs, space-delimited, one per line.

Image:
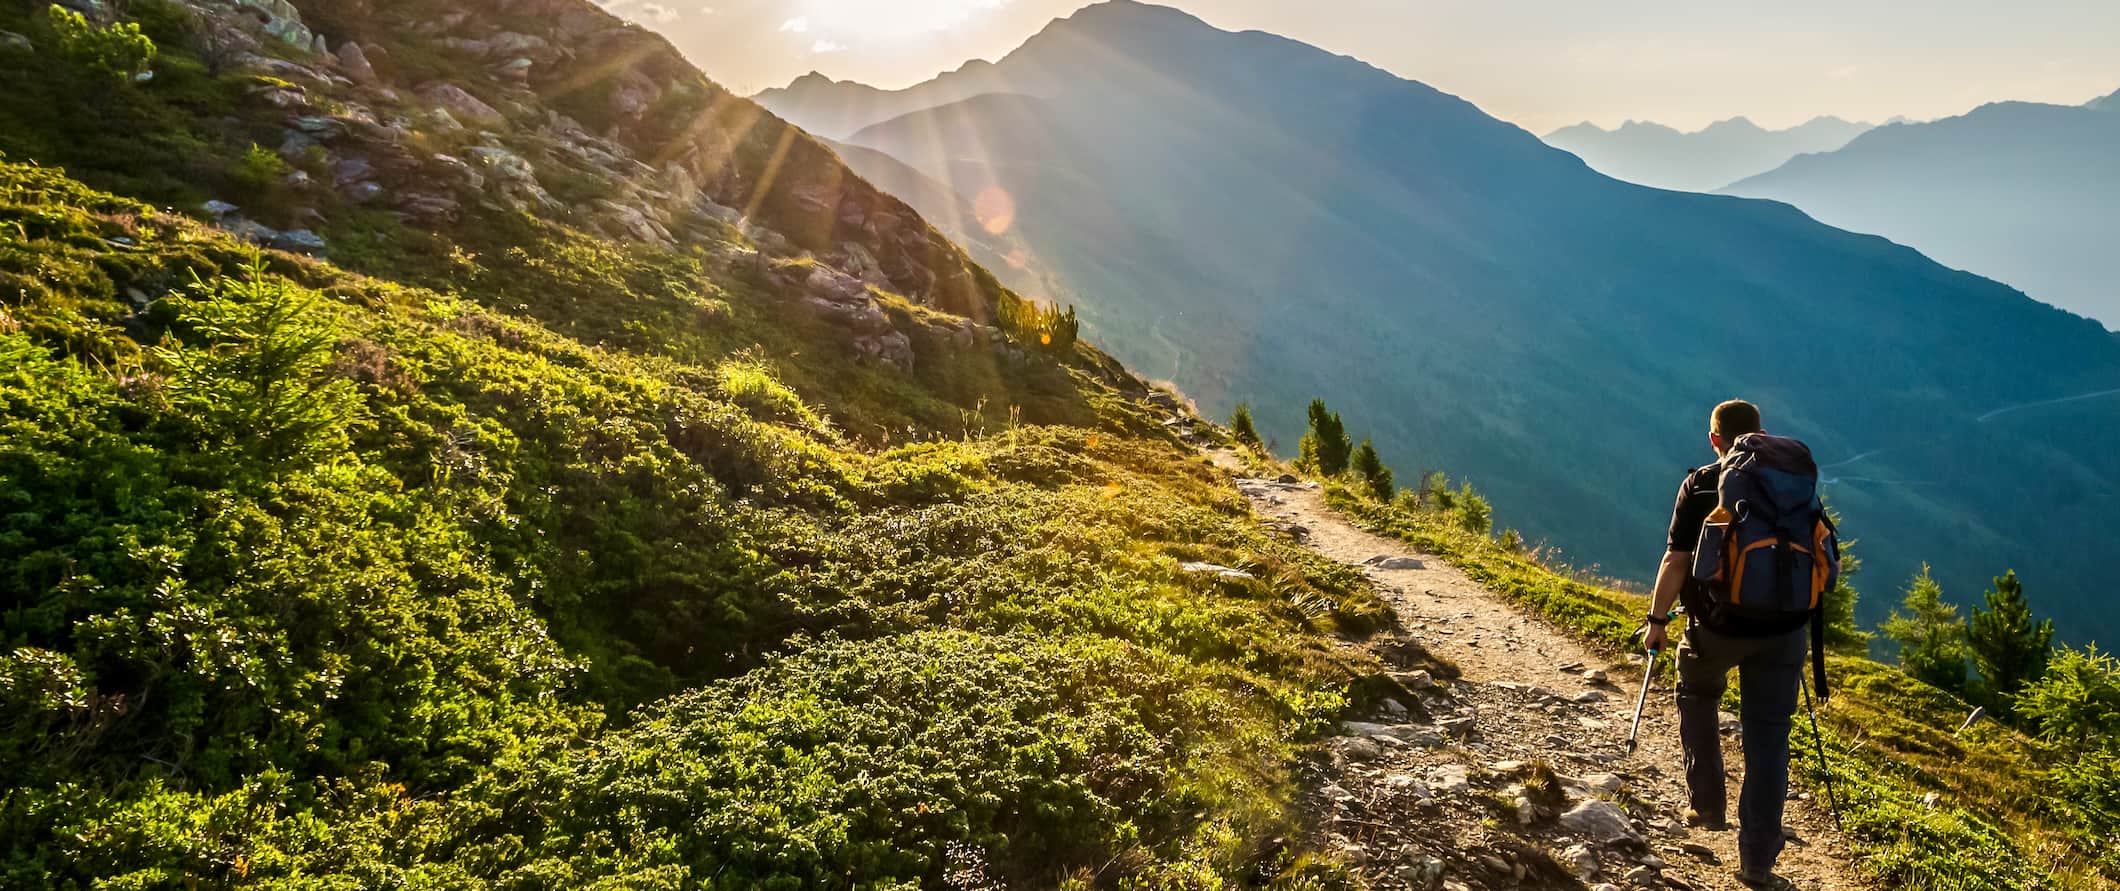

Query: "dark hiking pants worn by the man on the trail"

xmin=1679 ymin=624 xmax=1810 ymax=872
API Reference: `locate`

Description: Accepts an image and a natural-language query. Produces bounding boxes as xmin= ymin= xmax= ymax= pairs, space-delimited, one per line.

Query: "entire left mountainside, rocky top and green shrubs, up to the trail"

xmin=0 ymin=0 xmax=1386 ymax=889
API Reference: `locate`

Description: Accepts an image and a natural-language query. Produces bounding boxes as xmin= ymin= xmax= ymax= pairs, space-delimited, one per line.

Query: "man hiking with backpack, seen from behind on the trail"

xmin=1643 ymin=401 xmax=1840 ymax=887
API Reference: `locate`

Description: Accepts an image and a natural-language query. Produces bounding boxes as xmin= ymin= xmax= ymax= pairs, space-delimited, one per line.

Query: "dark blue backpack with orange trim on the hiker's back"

xmin=1694 ymin=433 xmax=1840 ymax=619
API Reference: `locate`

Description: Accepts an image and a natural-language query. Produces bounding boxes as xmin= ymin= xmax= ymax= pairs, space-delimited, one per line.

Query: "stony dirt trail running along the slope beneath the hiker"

xmin=1211 ymin=452 xmax=1863 ymax=891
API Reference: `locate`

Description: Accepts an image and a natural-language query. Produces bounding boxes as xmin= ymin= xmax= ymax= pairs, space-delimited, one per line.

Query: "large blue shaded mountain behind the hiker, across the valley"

xmin=788 ymin=2 xmax=2120 ymax=639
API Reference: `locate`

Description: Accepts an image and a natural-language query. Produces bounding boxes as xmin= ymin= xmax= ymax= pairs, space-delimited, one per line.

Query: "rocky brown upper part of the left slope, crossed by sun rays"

xmin=163 ymin=0 xmax=1026 ymax=371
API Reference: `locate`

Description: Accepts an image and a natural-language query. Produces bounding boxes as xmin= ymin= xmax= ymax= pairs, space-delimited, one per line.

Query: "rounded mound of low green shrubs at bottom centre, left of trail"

xmin=506 ymin=632 xmax=1305 ymax=887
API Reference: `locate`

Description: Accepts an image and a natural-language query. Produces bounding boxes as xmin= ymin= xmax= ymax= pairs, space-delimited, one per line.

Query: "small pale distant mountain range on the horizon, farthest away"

xmin=1545 ymin=117 xmax=1874 ymax=191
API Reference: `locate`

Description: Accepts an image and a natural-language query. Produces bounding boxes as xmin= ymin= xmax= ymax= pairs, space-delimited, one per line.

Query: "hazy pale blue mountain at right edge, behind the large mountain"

xmin=1724 ymin=98 xmax=2120 ymax=327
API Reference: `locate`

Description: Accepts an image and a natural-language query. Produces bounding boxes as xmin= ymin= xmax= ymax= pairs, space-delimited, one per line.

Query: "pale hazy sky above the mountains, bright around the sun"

xmin=602 ymin=0 xmax=2120 ymax=134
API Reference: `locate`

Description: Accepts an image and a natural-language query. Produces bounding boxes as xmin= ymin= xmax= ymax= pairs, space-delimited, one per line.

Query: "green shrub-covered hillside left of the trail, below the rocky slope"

xmin=0 ymin=134 xmax=1407 ymax=887
